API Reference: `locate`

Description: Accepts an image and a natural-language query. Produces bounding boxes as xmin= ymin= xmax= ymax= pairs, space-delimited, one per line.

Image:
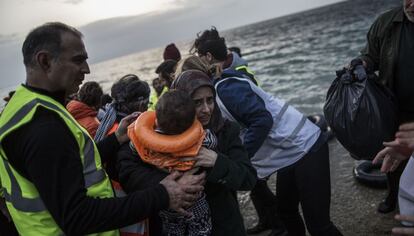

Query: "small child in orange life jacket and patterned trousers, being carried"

xmin=128 ymin=90 xmax=213 ymax=235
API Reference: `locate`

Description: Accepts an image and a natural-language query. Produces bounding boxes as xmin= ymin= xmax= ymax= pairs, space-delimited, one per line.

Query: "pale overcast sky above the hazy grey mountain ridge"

xmin=0 ymin=0 xmax=339 ymax=35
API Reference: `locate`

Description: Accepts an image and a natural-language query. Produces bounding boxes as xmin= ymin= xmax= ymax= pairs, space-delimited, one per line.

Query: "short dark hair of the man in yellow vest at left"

xmin=22 ymin=22 xmax=82 ymax=67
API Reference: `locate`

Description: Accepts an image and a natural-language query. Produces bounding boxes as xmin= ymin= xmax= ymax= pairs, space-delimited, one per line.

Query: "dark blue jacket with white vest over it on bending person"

xmin=215 ymin=69 xmax=321 ymax=178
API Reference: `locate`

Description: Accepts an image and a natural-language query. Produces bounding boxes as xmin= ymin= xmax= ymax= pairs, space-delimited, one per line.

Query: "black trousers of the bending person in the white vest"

xmin=276 ymin=140 xmax=342 ymax=236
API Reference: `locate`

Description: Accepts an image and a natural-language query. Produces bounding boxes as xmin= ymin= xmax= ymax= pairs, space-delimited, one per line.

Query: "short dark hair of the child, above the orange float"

xmin=155 ymin=90 xmax=196 ymax=134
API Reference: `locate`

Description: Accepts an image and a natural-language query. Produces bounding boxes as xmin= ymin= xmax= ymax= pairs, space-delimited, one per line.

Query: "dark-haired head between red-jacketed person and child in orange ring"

xmin=111 ymin=74 xmax=151 ymax=114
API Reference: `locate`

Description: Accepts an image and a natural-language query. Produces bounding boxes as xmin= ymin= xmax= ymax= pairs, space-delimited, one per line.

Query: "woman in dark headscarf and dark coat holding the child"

xmin=117 ymin=70 xmax=256 ymax=235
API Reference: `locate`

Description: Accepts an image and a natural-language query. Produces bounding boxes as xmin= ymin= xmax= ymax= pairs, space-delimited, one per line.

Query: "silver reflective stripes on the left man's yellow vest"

xmin=0 ymin=99 xmax=105 ymax=212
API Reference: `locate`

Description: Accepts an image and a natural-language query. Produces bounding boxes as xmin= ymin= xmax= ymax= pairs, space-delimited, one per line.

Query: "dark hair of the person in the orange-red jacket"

xmin=78 ymin=81 xmax=103 ymax=108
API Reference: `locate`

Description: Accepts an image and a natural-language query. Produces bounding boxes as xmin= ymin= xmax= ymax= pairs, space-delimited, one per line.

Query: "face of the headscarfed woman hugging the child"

xmin=192 ymin=87 xmax=214 ymax=126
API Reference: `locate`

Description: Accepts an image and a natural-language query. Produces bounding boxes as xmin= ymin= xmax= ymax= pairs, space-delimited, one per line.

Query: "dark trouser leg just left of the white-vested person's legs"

xmin=250 ymin=179 xmax=280 ymax=228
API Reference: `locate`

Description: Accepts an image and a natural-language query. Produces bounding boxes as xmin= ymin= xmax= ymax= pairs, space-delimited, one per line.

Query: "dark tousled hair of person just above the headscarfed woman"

xmin=190 ymin=26 xmax=227 ymax=61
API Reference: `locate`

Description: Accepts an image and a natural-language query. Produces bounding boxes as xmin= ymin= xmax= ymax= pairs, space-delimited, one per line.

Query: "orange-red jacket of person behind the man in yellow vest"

xmin=66 ymin=100 xmax=99 ymax=138
